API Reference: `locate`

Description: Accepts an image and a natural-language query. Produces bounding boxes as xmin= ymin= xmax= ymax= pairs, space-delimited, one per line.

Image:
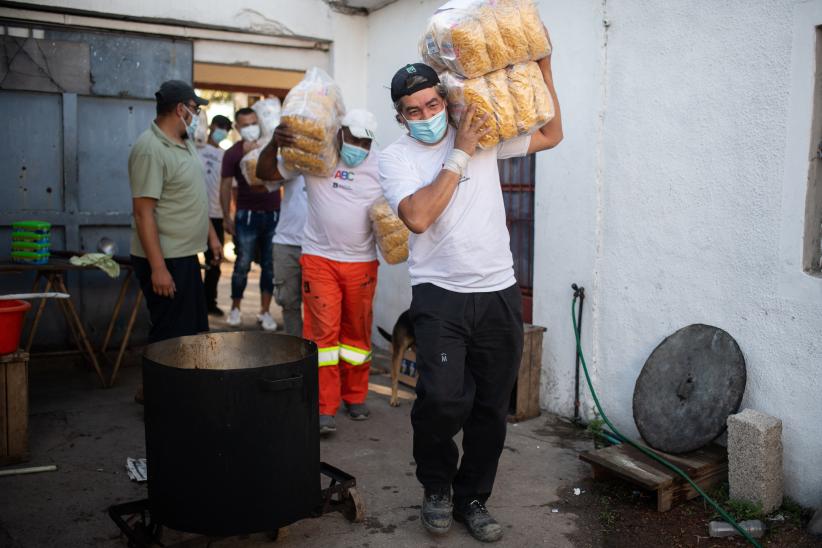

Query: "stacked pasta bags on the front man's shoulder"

xmin=420 ymin=0 xmax=554 ymax=149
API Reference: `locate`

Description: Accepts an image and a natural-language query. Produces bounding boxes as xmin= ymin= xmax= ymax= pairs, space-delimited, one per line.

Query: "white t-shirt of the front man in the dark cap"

xmin=380 ymin=126 xmax=531 ymax=293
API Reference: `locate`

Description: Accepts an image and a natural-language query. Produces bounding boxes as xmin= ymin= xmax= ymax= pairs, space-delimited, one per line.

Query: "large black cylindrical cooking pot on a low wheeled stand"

xmin=143 ymin=331 xmax=321 ymax=536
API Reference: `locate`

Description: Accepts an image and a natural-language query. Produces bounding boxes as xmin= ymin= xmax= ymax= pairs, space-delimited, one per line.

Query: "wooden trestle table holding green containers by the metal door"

xmin=0 ymin=260 xmax=143 ymax=387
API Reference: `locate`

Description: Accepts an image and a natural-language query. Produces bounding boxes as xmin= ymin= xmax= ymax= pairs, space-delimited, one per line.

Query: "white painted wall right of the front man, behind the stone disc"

xmin=535 ymin=0 xmax=822 ymax=505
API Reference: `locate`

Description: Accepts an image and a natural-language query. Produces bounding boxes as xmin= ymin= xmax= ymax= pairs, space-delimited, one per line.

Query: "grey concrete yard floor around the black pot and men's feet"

xmin=0 ymin=265 xmax=822 ymax=548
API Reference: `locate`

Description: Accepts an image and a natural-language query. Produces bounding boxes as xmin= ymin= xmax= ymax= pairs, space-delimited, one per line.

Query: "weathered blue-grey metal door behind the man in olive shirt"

xmin=0 ymin=20 xmax=192 ymax=346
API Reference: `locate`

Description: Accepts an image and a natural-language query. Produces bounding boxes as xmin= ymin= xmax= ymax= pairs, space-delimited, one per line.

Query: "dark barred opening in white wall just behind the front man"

xmin=499 ymin=154 xmax=536 ymax=323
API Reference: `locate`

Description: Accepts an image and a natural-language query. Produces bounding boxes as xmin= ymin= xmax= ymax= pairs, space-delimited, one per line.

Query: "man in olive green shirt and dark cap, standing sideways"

xmin=128 ymin=80 xmax=222 ymax=342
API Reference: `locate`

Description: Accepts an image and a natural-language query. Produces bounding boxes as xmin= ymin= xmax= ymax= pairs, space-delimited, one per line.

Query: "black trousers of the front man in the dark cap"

xmin=409 ymin=284 xmax=523 ymax=504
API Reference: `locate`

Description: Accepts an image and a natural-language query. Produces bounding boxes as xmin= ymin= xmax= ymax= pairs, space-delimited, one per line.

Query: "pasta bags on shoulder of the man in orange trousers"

xmin=280 ymin=67 xmax=345 ymax=177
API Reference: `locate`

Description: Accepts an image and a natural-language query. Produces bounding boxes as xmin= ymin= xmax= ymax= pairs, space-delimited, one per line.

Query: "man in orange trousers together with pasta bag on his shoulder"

xmin=257 ymin=69 xmax=382 ymax=435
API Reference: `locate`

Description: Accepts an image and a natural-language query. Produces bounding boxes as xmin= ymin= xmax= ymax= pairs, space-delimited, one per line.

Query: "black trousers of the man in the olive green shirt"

xmin=131 ymin=255 xmax=208 ymax=343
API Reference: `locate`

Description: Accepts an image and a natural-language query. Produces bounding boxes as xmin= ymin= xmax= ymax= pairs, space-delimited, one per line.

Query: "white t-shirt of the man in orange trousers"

xmin=279 ymin=149 xmax=382 ymax=263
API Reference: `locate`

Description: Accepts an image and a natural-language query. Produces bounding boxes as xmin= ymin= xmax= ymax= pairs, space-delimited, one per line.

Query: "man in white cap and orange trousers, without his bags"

xmin=257 ymin=109 xmax=382 ymax=434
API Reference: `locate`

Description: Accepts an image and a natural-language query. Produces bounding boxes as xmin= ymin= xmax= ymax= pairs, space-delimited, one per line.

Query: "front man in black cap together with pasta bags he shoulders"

xmin=380 ymin=0 xmax=562 ymax=542
